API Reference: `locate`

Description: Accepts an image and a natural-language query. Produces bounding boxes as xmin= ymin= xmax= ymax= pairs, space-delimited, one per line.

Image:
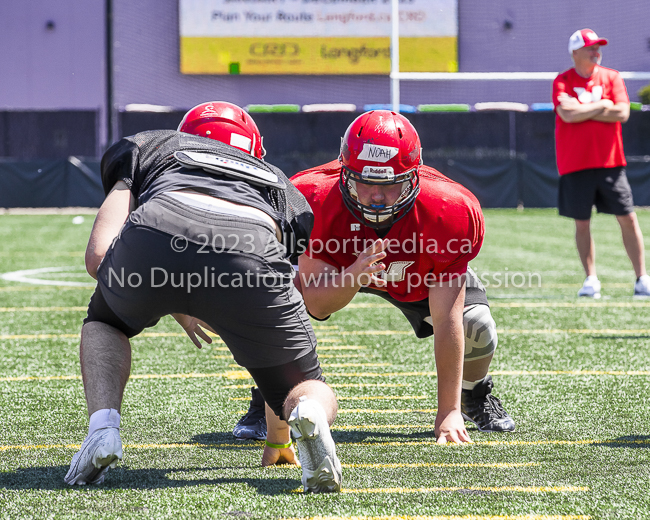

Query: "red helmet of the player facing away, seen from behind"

xmin=178 ymin=101 xmax=266 ymax=159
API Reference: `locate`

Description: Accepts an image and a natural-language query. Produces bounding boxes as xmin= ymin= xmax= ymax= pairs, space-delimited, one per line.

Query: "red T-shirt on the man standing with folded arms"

xmin=553 ymin=66 xmax=630 ymax=175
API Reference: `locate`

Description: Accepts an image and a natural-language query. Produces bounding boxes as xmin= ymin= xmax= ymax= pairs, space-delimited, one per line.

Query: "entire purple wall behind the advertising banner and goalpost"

xmin=0 ymin=0 xmax=650 ymax=150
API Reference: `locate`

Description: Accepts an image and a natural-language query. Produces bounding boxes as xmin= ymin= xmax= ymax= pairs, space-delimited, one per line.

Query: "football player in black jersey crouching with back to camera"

xmin=65 ymin=102 xmax=341 ymax=492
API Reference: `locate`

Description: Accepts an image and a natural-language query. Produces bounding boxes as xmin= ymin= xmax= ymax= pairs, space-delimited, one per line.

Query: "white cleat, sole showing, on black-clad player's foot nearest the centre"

xmin=288 ymin=397 xmax=342 ymax=493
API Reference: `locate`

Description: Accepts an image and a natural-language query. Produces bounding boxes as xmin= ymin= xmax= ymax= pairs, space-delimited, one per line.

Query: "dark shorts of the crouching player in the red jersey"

xmin=359 ymin=267 xmax=489 ymax=338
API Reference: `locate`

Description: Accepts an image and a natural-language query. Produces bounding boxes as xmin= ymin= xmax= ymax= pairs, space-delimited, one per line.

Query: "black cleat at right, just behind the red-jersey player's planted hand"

xmin=460 ymin=376 xmax=515 ymax=432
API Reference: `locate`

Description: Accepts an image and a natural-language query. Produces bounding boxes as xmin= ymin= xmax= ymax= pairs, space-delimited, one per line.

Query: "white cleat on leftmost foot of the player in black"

xmin=63 ymin=428 xmax=122 ymax=486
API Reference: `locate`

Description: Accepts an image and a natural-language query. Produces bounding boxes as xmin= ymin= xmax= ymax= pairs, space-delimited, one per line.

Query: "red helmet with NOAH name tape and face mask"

xmin=339 ymin=110 xmax=422 ymax=229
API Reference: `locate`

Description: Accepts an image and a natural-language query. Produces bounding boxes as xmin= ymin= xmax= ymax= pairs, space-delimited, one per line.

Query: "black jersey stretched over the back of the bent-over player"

xmin=101 ymin=130 xmax=314 ymax=261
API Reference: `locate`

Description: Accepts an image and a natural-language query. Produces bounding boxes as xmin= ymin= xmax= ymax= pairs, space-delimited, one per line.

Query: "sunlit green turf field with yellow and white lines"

xmin=0 ymin=209 xmax=650 ymax=520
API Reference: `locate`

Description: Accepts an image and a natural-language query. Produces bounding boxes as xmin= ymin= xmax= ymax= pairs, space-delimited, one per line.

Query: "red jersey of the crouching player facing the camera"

xmin=291 ymin=160 xmax=485 ymax=302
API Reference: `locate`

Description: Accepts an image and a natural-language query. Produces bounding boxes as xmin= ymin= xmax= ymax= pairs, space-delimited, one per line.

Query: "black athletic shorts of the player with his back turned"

xmin=84 ymin=195 xmax=323 ymax=414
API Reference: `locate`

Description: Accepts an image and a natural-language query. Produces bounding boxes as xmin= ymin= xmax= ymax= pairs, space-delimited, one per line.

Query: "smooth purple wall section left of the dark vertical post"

xmin=0 ymin=0 xmax=105 ymax=109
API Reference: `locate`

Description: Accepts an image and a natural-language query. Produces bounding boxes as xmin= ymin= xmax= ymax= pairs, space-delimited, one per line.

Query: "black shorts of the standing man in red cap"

xmin=558 ymin=166 xmax=634 ymax=220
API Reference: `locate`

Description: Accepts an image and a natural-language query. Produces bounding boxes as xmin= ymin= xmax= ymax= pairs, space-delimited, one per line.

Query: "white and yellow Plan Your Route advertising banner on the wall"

xmin=179 ymin=0 xmax=458 ymax=74
